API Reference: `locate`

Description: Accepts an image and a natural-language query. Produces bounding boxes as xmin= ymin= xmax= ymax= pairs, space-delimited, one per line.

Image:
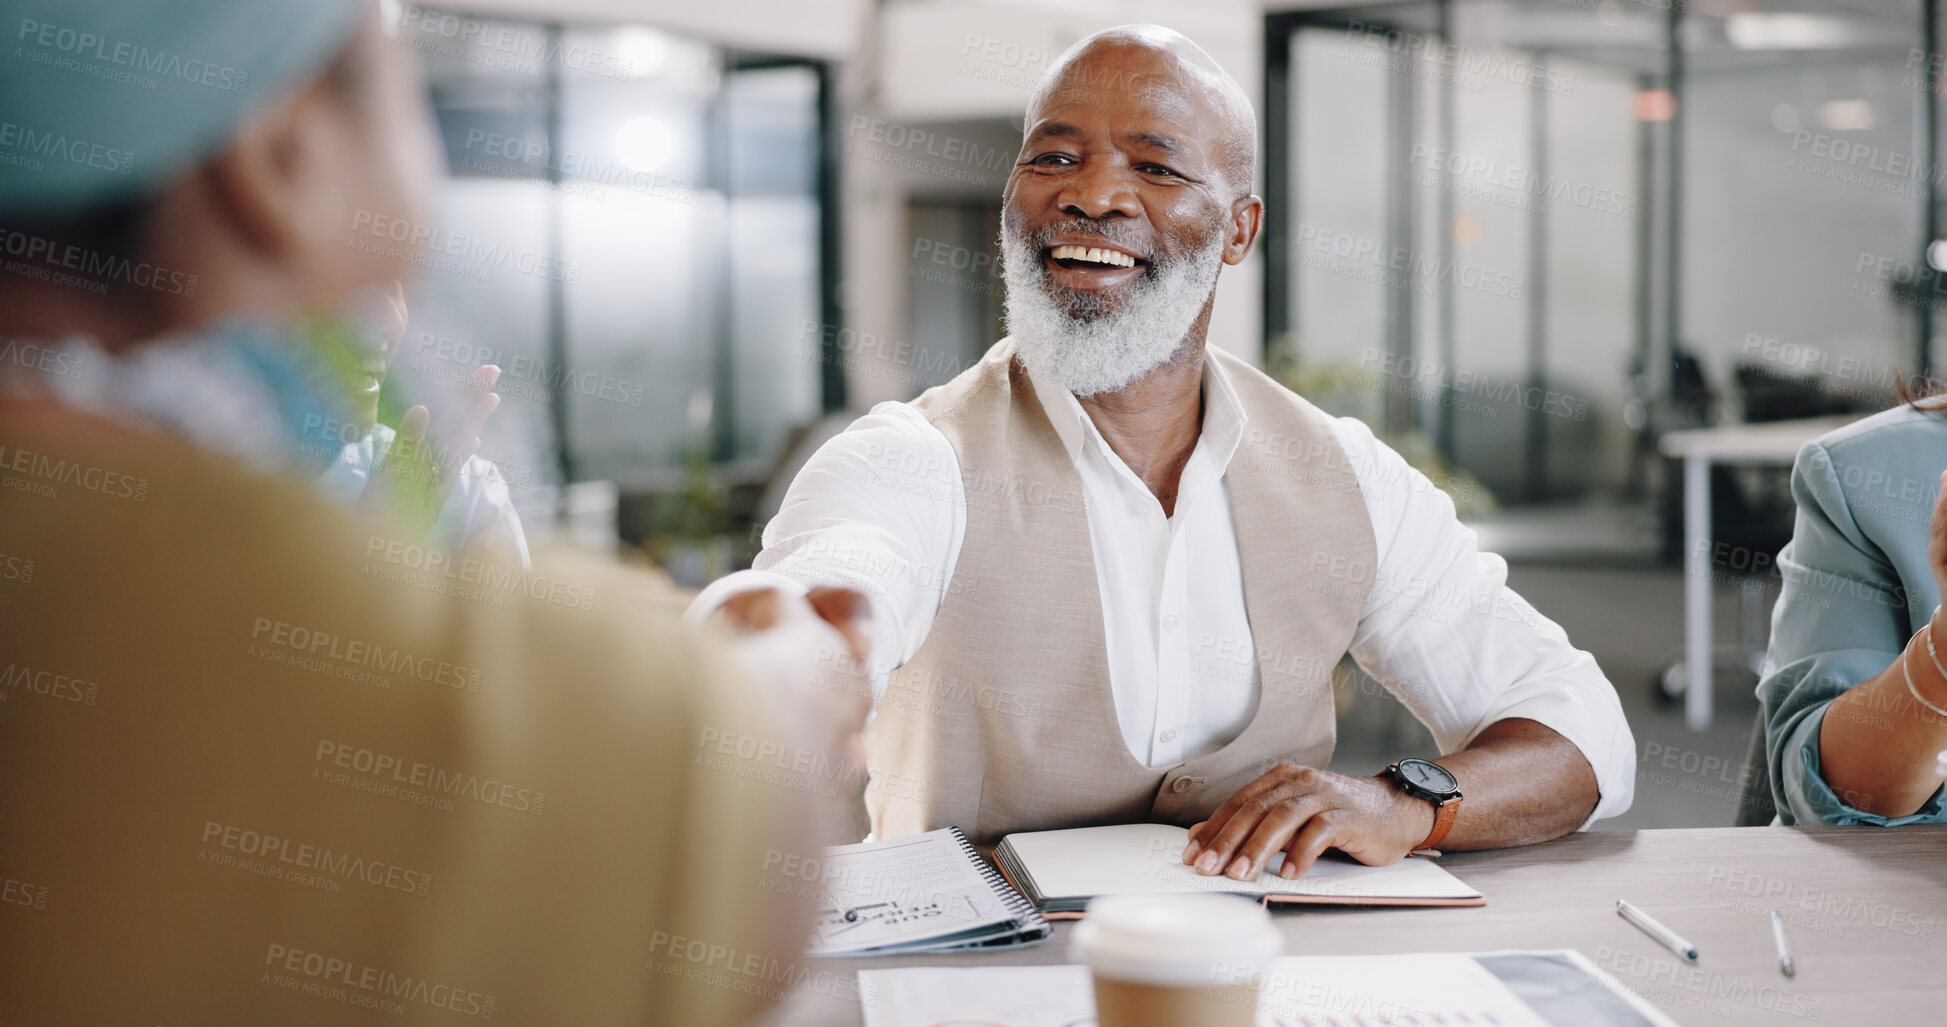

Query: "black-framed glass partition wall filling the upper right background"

xmin=1266 ymin=0 xmax=1947 ymax=509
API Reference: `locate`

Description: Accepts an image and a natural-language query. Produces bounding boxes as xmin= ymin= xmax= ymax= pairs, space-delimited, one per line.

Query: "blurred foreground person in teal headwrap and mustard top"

xmin=0 ymin=0 xmax=863 ymax=1027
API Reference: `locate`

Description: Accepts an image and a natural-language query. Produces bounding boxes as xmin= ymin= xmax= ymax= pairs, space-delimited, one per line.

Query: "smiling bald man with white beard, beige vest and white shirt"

xmin=693 ymin=25 xmax=1634 ymax=877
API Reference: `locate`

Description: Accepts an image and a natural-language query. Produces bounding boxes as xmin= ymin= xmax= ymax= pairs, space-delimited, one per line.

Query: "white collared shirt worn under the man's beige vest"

xmin=691 ymin=348 xmax=1635 ymax=820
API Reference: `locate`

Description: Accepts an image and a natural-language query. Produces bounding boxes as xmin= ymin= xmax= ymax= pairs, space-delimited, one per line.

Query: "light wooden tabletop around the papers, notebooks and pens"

xmin=765 ymin=826 xmax=1947 ymax=1027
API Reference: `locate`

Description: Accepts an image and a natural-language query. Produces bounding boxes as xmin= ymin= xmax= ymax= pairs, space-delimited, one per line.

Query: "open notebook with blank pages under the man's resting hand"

xmin=995 ymin=824 xmax=1488 ymax=918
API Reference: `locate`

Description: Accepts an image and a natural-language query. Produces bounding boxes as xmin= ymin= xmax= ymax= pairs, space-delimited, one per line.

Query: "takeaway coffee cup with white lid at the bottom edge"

xmin=1069 ymin=894 xmax=1285 ymax=1027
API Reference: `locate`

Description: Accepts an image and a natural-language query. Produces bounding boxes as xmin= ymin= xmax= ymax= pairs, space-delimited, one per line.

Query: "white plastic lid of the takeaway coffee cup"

xmin=1069 ymin=894 xmax=1285 ymax=986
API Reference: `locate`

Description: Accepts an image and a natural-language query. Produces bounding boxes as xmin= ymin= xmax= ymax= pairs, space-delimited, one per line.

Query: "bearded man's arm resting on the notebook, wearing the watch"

xmin=1186 ymin=421 xmax=1635 ymax=875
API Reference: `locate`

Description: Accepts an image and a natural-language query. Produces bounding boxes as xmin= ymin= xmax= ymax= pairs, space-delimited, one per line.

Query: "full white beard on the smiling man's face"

xmin=1001 ymin=228 xmax=1223 ymax=396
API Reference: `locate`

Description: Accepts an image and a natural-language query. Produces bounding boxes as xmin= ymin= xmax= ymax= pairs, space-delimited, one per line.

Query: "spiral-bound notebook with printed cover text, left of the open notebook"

xmin=806 ymin=828 xmax=1053 ymax=955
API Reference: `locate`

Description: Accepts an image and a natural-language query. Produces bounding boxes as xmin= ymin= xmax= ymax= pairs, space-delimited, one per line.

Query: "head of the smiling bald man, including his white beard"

xmin=1001 ymin=25 xmax=1264 ymax=396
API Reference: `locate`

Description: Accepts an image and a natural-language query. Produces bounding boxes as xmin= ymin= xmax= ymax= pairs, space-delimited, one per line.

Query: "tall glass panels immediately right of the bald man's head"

xmin=1266 ymin=0 xmax=1663 ymax=501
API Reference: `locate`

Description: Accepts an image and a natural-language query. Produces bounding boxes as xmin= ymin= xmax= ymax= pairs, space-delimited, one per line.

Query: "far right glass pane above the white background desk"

xmin=1678 ymin=0 xmax=1939 ymax=417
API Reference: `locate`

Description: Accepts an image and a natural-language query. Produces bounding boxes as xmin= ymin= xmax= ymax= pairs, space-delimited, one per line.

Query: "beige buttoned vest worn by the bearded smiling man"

xmin=866 ymin=339 xmax=1375 ymax=844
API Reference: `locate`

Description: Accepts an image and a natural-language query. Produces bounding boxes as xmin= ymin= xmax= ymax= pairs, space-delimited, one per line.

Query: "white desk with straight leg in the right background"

xmin=1657 ymin=417 xmax=1855 ymax=731
